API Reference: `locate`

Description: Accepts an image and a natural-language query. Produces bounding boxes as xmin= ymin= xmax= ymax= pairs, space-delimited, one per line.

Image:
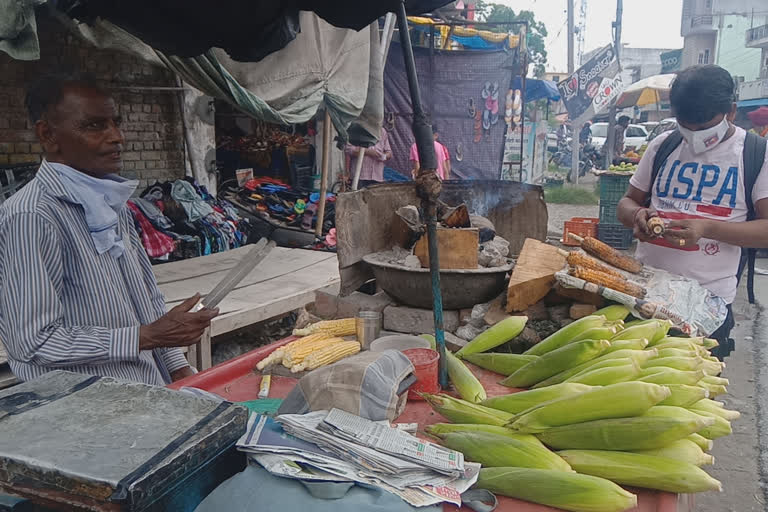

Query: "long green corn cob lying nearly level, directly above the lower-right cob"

xmin=536 ymin=415 xmax=714 ymax=451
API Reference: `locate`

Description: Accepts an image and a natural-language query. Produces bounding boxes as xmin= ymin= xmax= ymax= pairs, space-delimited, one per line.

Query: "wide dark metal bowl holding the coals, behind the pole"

xmin=363 ymin=254 xmax=514 ymax=310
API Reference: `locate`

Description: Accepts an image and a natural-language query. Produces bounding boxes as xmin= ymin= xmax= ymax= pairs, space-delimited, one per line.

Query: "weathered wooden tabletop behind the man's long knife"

xmin=155 ymin=247 xmax=338 ymax=302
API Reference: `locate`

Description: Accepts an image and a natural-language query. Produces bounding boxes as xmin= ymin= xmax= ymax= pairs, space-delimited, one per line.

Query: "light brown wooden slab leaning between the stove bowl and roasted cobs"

xmin=507 ymin=238 xmax=565 ymax=313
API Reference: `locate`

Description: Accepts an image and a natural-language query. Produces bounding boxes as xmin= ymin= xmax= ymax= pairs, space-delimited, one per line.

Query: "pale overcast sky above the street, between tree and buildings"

xmin=492 ymin=0 xmax=683 ymax=72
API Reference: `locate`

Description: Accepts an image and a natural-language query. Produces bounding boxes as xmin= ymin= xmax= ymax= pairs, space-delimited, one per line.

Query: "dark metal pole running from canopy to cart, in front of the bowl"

xmin=397 ymin=0 xmax=448 ymax=389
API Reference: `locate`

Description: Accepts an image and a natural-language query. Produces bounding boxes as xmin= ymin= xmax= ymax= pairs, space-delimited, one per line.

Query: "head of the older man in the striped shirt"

xmin=35 ymin=85 xmax=124 ymax=178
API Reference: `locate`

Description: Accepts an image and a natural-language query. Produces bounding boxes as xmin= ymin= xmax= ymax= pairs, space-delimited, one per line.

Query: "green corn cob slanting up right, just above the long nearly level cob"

xmin=509 ymin=382 xmax=670 ymax=434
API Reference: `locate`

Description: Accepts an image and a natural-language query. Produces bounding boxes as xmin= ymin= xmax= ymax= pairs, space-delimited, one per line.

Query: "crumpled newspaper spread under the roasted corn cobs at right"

xmin=555 ymin=252 xmax=728 ymax=336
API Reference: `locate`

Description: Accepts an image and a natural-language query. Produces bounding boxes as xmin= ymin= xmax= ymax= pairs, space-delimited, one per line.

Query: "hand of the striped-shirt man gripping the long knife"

xmin=139 ymin=293 xmax=219 ymax=350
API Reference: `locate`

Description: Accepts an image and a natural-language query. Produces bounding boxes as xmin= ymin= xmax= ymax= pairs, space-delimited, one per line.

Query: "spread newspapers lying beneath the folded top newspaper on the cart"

xmin=237 ymin=411 xmax=480 ymax=507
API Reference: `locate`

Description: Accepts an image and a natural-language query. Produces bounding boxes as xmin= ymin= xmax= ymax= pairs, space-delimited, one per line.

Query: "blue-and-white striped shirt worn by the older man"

xmin=0 ymin=161 xmax=187 ymax=385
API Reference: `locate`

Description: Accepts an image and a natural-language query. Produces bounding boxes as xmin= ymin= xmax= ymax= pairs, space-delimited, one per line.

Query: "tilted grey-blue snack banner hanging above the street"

xmin=557 ymin=45 xmax=624 ymax=125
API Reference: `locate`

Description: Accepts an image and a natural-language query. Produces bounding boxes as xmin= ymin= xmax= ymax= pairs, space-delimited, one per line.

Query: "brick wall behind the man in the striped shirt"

xmin=0 ymin=16 xmax=184 ymax=188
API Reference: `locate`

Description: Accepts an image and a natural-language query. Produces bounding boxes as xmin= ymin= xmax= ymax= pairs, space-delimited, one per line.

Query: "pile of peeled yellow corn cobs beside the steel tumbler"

xmin=256 ymin=318 xmax=360 ymax=373
